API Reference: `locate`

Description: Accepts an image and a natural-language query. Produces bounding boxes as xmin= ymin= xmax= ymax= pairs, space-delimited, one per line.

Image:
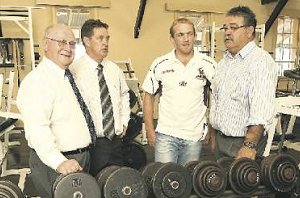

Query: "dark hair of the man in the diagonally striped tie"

xmin=81 ymin=19 xmax=109 ymax=44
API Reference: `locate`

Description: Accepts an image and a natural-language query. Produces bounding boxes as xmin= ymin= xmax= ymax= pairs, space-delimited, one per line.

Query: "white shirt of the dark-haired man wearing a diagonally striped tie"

xmin=70 ymin=53 xmax=130 ymax=137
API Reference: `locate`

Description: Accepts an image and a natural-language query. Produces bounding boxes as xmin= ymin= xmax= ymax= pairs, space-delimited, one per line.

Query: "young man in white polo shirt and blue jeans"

xmin=143 ymin=18 xmax=216 ymax=165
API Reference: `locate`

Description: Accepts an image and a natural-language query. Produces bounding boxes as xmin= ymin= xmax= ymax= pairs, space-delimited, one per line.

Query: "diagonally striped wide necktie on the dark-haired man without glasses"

xmin=97 ymin=64 xmax=115 ymax=140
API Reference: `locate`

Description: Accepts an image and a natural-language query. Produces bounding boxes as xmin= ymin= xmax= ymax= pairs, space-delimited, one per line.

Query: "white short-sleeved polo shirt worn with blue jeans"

xmin=142 ymin=50 xmax=216 ymax=141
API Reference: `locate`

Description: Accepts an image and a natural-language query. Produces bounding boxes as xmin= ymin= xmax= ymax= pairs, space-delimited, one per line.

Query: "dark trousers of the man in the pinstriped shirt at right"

xmin=216 ymin=131 xmax=268 ymax=158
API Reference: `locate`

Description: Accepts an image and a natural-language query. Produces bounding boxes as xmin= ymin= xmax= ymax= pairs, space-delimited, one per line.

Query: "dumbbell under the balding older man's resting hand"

xmin=52 ymin=172 xmax=101 ymax=198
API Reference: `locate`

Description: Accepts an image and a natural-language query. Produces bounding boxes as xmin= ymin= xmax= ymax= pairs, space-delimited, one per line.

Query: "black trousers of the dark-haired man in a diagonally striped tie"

xmin=90 ymin=137 xmax=124 ymax=176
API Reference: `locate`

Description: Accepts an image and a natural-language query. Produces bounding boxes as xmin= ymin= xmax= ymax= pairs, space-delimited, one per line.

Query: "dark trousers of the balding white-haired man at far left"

xmin=29 ymin=150 xmax=90 ymax=198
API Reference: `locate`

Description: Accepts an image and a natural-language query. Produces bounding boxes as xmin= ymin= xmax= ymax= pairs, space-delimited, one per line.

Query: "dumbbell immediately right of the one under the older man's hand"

xmin=96 ymin=165 xmax=148 ymax=198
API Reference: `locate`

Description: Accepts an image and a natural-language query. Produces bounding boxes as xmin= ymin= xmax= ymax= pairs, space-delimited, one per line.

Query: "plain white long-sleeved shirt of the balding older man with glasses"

xmin=17 ymin=57 xmax=91 ymax=170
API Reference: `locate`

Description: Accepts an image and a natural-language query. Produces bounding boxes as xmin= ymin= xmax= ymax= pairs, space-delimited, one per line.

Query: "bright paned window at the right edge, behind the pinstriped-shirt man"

xmin=275 ymin=16 xmax=299 ymax=76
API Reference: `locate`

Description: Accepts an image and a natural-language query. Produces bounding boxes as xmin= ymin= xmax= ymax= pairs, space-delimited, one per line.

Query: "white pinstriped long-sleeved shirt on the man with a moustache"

xmin=210 ymin=41 xmax=277 ymax=137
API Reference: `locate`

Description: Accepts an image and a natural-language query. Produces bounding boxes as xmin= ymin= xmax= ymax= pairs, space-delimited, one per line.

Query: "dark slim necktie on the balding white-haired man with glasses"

xmin=65 ymin=69 xmax=97 ymax=144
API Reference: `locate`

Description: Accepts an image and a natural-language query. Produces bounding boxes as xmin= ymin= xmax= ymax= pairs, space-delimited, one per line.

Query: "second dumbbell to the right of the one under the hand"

xmin=141 ymin=162 xmax=192 ymax=198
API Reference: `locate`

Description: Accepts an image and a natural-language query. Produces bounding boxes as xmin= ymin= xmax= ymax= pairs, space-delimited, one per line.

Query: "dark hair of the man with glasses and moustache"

xmin=226 ymin=6 xmax=257 ymax=37
